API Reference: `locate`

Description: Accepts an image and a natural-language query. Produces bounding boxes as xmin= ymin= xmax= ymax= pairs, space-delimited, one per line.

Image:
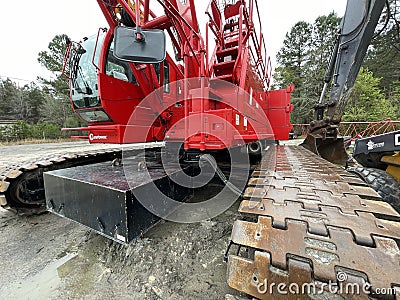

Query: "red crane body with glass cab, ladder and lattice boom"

xmin=65 ymin=0 xmax=293 ymax=151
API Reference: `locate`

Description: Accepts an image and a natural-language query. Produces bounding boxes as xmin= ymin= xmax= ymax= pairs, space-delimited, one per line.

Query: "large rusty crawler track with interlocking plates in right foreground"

xmin=227 ymin=146 xmax=400 ymax=299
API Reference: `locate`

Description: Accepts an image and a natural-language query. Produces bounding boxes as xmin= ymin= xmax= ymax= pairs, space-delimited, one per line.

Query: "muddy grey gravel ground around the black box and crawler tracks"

xmin=0 ymin=143 xmax=248 ymax=299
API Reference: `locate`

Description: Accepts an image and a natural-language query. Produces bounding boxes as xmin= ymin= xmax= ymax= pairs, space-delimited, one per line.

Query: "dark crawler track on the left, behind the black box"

xmin=0 ymin=148 xmax=140 ymax=210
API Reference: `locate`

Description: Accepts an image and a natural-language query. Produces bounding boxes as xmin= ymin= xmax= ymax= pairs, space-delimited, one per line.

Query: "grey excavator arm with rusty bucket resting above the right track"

xmin=303 ymin=0 xmax=386 ymax=164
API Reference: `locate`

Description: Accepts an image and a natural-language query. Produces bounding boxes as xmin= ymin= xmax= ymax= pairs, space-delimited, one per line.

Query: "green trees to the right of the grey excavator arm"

xmin=346 ymin=0 xmax=400 ymax=121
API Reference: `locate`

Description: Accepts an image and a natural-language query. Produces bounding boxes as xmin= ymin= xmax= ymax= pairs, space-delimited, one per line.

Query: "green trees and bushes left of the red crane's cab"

xmin=0 ymin=34 xmax=82 ymax=141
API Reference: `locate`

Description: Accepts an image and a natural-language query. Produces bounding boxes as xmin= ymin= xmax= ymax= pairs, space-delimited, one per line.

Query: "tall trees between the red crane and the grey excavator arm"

xmin=275 ymin=13 xmax=340 ymax=123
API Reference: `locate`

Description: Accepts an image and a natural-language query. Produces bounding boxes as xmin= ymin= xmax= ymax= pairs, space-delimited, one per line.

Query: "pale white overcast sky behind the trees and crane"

xmin=0 ymin=0 xmax=346 ymax=83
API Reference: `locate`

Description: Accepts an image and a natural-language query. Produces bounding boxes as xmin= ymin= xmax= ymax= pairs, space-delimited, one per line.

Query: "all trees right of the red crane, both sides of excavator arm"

xmin=275 ymin=10 xmax=400 ymax=123
